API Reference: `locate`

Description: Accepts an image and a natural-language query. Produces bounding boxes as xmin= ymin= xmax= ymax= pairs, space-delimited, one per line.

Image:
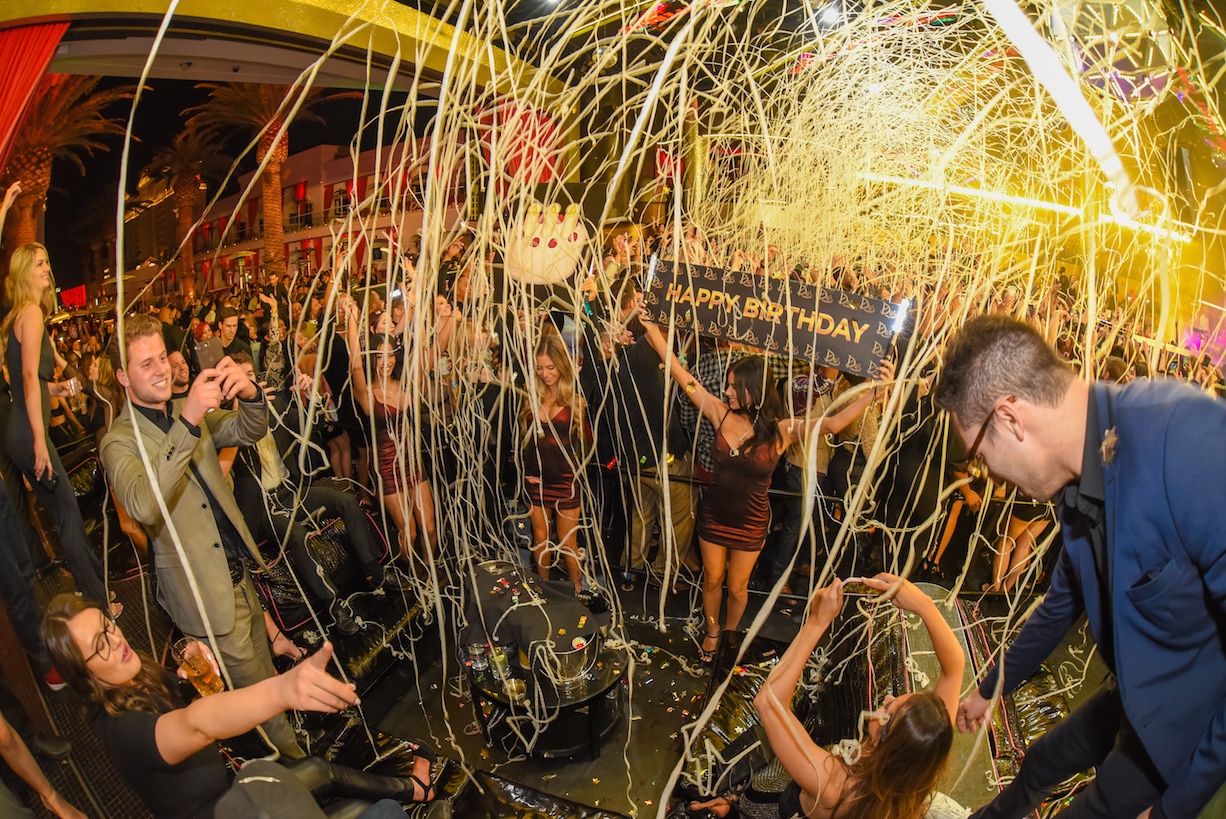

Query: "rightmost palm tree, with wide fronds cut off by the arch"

xmin=184 ymin=82 xmax=362 ymax=277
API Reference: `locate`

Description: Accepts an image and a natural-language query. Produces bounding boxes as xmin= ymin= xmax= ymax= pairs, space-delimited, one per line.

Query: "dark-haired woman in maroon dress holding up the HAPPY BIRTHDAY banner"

xmin=644 ymin=322 xmax=894 ymax=662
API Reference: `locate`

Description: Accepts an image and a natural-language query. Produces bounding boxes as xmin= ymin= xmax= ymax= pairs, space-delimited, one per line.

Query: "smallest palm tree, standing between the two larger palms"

xmin=145 ymin=126 xmax=230 ymax=293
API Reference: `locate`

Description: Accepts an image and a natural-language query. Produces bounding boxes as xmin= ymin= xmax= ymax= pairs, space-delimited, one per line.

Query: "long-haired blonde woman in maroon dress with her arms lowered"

xmin=520 ymin=327 xmax=592 ymax=593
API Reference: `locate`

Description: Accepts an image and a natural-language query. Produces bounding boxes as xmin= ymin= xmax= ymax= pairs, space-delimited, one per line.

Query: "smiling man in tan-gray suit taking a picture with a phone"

xmin=101 ymin=315 xmax=304 ymax=759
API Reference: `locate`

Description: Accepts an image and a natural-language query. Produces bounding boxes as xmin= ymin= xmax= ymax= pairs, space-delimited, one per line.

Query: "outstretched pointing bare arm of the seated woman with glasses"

xmin=154 ymin=642 xmax=360 ymax=765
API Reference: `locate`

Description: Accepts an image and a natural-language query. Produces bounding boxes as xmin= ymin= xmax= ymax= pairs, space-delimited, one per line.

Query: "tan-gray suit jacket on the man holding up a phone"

xmin=101 ymin=398 xmax=268 ymax=636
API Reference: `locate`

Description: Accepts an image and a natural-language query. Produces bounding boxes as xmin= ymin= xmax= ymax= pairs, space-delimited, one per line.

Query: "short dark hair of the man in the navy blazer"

xmin=934 ymin=315 xmax=1073 ymax=428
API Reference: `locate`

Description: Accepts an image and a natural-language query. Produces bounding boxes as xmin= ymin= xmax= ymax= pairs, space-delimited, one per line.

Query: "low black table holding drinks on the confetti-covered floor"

xmin=465 ymin=649 xmax=628 ymax=759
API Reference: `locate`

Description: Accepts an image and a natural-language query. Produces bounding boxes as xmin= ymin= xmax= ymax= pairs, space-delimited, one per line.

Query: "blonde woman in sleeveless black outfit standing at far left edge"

xmin=0 ymin=243 xmax=114 ymax=614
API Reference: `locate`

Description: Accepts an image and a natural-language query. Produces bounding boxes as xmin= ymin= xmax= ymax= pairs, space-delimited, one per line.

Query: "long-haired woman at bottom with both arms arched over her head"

xmin=690 ymin=573 xmax=970 ymax=819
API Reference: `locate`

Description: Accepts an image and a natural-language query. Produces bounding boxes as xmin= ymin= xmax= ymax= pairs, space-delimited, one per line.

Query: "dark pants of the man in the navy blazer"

xmin=971 ymin=679 xmax=1166 ymax=819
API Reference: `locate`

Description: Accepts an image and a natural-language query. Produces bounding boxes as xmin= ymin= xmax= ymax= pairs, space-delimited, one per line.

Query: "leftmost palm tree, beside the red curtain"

xmin=0 ymin=74 xmax=136 ymax=259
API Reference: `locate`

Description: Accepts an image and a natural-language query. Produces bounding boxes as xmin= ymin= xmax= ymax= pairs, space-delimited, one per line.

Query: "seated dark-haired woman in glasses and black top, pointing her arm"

xmin=43 ymin=595 xmax=449 ymax=819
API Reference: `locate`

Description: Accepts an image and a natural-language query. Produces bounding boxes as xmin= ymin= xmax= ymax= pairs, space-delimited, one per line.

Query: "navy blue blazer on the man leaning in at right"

xmin=981 ymin=379 xmax=1226 ymax=819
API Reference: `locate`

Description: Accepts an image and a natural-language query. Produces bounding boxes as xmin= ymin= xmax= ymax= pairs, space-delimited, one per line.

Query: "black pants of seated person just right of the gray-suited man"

xmin=272 ymin=487 xmax=383 ymax=604
